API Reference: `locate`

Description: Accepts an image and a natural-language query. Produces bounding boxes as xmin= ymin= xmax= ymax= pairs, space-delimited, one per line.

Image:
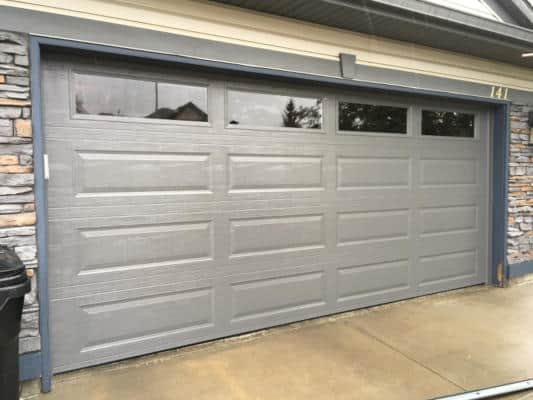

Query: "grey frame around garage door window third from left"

xmin=335 ymin=95 xmax=416 ymax=138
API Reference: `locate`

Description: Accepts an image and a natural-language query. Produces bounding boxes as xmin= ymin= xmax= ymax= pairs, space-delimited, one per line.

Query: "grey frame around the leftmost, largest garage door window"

xmin=68 ymin=67 xmax=213 ymax=127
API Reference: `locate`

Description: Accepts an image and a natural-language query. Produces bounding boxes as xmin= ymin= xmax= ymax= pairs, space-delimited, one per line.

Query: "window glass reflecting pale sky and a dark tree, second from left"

xmin=228 ymin=90 xmax=322 ymax=129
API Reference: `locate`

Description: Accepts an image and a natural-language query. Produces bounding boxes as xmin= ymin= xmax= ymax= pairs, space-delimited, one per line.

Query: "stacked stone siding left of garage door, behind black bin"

xmin=0 ymin=32 xmax=41 ymax=353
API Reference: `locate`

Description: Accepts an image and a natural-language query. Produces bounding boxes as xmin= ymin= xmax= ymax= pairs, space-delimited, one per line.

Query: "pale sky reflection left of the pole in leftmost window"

xmin=74 ymin=75 xmax=155 ymax=117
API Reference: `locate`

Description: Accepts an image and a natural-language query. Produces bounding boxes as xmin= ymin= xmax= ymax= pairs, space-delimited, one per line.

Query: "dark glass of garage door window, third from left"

xmin=339 ymin=102 xmax=407 ymax=133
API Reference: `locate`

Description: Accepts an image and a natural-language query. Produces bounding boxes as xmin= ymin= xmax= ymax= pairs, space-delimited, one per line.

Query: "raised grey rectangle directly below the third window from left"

xmin=337 ymin=157 xmax=410 ymax=190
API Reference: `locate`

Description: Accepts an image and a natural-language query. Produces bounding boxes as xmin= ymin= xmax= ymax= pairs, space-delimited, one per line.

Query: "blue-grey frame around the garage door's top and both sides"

xmin=30 ymin=36 xmax=510 ymax=392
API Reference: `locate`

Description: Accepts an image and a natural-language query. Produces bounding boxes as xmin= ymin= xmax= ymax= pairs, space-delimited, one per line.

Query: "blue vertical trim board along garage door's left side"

xmin=30 ymin=37 xmax=52 ymax=393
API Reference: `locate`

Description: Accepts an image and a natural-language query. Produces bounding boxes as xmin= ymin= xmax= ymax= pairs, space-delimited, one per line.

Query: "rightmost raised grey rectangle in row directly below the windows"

xmin=420 ymin=160 xmax=477 ymax=185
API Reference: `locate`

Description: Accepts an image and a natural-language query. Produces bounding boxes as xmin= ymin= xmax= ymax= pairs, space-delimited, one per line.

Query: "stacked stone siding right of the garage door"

xmin=507 ymin=105 xmax=533 ymax=264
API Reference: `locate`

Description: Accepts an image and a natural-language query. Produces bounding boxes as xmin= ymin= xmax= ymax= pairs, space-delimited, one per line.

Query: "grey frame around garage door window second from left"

xmin=224 ymin=82 xmax=327 ymax=135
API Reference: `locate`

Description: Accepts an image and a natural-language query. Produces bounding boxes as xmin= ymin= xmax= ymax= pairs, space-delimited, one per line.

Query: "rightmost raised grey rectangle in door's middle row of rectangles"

xmin=420 ymin=206 xmax=477 ymax=234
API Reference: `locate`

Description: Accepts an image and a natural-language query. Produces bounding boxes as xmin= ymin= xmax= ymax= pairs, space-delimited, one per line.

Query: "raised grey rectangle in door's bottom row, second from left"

xmin=232 ymin=272 xmax=326 ymax=321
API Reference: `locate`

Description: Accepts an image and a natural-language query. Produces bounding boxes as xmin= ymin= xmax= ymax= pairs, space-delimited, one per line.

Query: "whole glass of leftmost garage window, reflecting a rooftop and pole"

xmin=74 ymin=74 xmax=207 ymax=122
